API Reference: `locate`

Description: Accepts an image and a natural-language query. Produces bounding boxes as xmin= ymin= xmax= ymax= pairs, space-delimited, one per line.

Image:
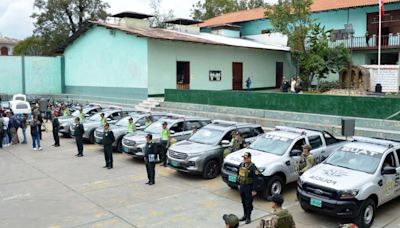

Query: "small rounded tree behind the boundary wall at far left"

xmin=13 ymin=36 xmax=46 ymax=56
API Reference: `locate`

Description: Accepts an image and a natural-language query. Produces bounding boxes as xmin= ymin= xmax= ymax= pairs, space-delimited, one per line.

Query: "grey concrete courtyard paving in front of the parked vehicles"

xmin=0 ymin=125 xmax=400 ymax=227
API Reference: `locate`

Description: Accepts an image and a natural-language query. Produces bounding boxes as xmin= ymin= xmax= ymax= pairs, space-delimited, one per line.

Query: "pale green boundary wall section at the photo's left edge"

xmin=0 ymin=56 xmax=22 ymax=94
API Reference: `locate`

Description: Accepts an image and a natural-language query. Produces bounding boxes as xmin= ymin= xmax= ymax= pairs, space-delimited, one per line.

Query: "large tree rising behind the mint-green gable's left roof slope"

xmin=31 ymin=0 xmax=109 ymax=54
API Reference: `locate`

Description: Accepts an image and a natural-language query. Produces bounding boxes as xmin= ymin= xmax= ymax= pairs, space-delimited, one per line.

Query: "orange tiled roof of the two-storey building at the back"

xmin=199 ymin=0 xmax=400 ymax=27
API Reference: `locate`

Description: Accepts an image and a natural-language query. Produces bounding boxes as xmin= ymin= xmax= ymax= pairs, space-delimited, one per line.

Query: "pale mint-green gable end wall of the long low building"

xmin=64 ymin=27 xmax=148 ymax=98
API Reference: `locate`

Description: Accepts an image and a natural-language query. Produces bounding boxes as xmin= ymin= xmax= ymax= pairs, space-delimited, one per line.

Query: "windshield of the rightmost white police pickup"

xmin=326 ymin=150 xmax=382 ymax=174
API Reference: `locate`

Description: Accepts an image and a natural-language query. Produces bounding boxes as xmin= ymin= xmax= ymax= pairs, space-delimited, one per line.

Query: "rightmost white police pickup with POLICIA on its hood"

xmin=297 ymin=137 xmax=400 ymax=227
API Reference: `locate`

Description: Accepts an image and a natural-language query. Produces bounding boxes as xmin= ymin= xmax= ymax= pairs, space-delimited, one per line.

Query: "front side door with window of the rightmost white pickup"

xmin=379 ymin=152 xmax=398 ymax=204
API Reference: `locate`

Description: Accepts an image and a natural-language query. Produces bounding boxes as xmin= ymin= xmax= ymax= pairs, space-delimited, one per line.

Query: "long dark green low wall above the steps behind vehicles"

xmin=165 ymin=90 xmax=400 ymax=120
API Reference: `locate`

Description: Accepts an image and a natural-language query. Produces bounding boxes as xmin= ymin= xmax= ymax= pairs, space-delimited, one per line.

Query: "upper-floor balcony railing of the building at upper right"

xmin=329 ymin=33 xmax=400 ymax=49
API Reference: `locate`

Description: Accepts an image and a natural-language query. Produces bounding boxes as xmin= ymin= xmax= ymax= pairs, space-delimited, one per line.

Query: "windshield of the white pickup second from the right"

xmin=249 ymin=134 xmax=293 ymax=155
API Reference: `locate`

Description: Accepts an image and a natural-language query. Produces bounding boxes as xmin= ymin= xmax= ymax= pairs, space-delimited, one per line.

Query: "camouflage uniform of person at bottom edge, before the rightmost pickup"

xmin=257 ymin=208 xmax=296 ymax=228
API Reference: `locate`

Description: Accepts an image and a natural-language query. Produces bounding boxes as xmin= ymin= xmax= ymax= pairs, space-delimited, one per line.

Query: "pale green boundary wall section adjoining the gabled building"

xmin=25 ymin=57 xmax=61 ymax=94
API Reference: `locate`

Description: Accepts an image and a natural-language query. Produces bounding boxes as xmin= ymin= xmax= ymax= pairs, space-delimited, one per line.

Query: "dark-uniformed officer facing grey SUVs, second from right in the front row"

xmin=144 ymin=134 xmax=157 ymax=185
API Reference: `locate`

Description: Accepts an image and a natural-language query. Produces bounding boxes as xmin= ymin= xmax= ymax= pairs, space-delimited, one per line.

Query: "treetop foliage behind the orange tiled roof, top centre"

xmin=191 ymin=0 xmax=265 ymax=20
